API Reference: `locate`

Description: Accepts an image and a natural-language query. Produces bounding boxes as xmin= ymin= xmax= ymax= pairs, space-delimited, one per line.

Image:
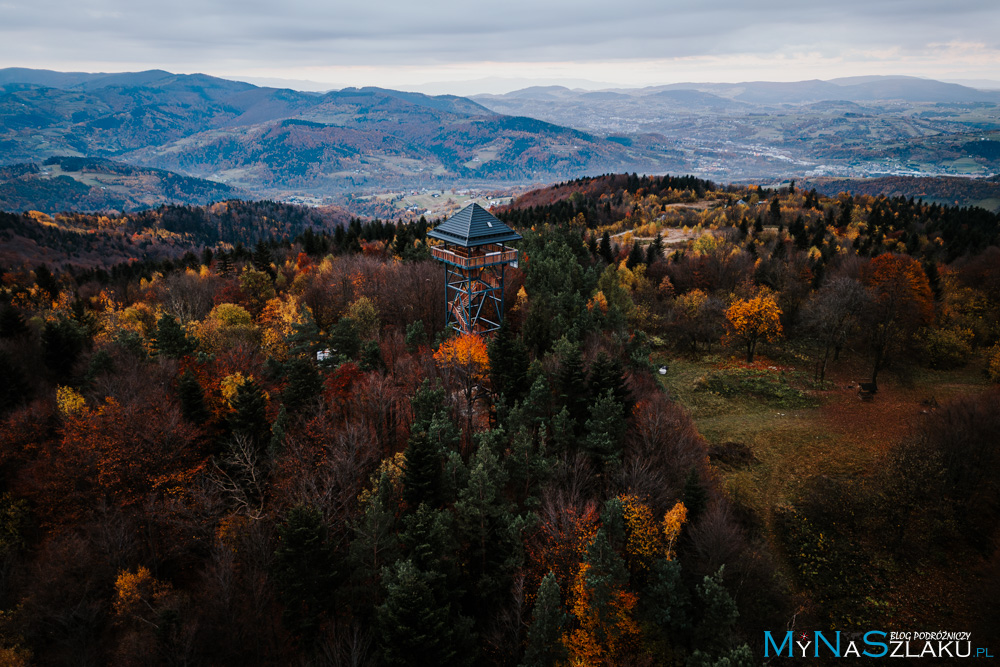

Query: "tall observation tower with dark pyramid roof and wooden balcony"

xmin=427 ymin=204 xmax=521 ymax=335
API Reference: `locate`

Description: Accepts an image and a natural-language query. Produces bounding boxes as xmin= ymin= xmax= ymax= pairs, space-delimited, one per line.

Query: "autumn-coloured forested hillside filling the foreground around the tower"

xmin=0 ymin=175 xmax=1000 ymax=667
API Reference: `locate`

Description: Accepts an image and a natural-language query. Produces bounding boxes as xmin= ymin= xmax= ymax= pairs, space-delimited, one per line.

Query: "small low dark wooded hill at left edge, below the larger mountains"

xmin=0 ymin=157 xmax=248 ymax=213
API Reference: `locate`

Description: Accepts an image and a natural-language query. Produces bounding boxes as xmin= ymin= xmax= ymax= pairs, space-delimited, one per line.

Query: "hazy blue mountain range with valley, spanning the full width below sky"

xmin=0 ymin=68 xmax=1000 ymax=207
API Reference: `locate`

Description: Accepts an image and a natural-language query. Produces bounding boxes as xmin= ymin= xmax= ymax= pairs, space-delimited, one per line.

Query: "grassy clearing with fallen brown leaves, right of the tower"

xmin=660 ymin=353 xmax=988 ymax=522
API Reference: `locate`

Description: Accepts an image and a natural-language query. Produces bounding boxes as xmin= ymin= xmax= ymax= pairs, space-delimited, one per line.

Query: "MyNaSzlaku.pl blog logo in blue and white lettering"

xmin=764 ymin=630 xmax=996 ymax=659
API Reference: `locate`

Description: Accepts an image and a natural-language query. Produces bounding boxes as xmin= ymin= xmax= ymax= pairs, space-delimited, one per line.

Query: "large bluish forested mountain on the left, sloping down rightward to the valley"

xmin=0 ymin=69 xmax=676 ymax=196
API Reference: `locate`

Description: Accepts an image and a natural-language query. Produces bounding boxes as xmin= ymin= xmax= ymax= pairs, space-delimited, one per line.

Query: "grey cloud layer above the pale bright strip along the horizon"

xmin=0 ymin=0 xmax=1000 ymax=67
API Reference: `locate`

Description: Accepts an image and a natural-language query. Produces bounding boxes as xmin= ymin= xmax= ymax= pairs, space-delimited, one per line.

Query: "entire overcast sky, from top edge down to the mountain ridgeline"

xmin=0 ymin=0 xmax=1000 ymax=94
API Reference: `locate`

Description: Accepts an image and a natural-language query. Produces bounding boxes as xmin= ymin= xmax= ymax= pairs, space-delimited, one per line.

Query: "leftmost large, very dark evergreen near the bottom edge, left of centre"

xmin=274 ymin=505 xmax=336 ymax=646
